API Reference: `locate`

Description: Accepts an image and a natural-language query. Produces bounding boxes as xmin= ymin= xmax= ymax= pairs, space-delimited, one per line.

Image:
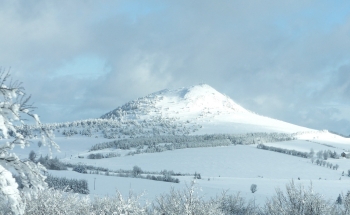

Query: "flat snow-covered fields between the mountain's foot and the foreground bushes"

xmin=10 ymin=134 xmax=350 ymax=206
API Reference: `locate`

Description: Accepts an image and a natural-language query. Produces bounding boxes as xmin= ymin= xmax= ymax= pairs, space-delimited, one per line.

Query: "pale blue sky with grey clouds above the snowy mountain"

xmin=0 ymin=0 xmax=350 ymax=135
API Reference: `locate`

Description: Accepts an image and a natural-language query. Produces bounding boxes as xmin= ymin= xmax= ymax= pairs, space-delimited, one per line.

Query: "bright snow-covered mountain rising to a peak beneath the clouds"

xmin=101 ymin=84 xmax=311 ymax=134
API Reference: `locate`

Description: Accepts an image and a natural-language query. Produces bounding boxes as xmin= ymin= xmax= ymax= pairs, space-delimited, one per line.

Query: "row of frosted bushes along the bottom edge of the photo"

xmin=0 ymin=181 xmax=350 ymax=215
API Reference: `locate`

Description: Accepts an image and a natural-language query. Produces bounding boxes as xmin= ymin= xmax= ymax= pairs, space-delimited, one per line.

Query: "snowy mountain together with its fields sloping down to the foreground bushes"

xmin=10 ymin=84 xmax=350 ymax=207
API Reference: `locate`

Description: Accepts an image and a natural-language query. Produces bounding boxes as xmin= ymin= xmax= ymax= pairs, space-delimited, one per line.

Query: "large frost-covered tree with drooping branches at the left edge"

xmin=0 ymin=70 xmax=58 ymax=214
